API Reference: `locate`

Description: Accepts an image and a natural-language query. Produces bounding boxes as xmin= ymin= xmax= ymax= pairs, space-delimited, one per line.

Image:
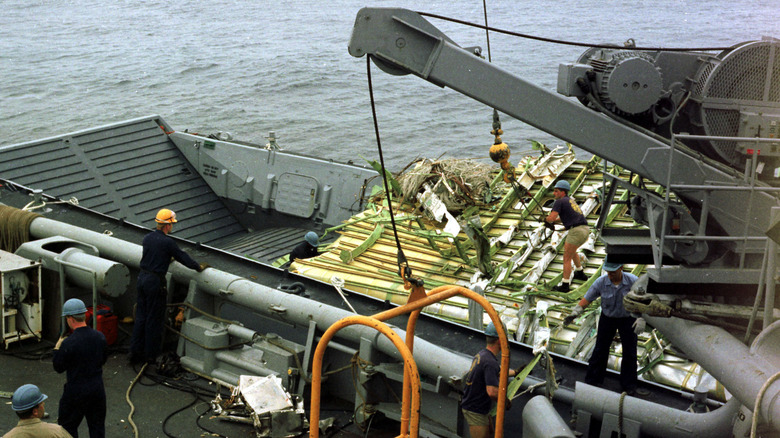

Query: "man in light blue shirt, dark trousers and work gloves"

xmin=563 ymin=259 xmax=646 ymax=395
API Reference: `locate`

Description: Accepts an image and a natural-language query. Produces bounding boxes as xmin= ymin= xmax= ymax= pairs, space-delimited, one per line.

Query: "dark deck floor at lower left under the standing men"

xmin=0 ymin=338 xmax=398 ymax=438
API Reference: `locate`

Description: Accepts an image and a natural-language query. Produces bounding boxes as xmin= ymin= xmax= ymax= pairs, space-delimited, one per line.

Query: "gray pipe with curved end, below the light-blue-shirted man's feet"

xmin=572 ymin=382 xmax=741 ymax=438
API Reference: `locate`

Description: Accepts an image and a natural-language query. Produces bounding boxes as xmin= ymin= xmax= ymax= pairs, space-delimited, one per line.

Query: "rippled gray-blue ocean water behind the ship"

xmin=0 ymin=0 xmax=780 ymax=170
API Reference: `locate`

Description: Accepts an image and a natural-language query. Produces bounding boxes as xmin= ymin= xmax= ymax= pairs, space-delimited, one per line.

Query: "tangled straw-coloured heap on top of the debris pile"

xmin=398 ymin=158 xmax=495 ymax=215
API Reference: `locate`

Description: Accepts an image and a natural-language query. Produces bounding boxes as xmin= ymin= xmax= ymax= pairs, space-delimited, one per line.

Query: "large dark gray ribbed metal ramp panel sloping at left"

xmin=0 ymin=116 xmax=245 ymax=244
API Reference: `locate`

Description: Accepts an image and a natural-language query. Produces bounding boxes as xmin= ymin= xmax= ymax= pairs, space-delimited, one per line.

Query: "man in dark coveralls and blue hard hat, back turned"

xmin=52 ymin=298 xmax=108 ymax=438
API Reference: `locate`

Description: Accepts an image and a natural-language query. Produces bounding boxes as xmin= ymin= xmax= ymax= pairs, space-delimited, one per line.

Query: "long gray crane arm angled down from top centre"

xmin=349 ymin=8 xmax=777 ymax=248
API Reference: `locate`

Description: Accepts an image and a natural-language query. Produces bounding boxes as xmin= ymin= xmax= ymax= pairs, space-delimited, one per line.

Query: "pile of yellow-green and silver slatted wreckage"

xmin=291 ymin=148 xmax=725 ymax=400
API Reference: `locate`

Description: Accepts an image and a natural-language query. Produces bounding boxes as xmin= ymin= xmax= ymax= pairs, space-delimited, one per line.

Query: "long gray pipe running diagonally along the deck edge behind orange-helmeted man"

xmin=30 ymin=217 xmax=471 ymax=377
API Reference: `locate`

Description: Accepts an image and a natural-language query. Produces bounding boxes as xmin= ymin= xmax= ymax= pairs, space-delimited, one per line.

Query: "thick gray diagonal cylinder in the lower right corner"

xmin=645 ymin=316 xmax=780 ymax=429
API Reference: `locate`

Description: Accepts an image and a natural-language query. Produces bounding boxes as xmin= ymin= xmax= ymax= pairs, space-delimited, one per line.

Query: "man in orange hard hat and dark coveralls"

xmin=129 ymin=208 xmax=209 ymax=364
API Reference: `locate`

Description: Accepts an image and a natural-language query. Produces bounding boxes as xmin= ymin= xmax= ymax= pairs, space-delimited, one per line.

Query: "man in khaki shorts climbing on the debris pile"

xmin=544 ymin=180 xmax=590 ymax=292
